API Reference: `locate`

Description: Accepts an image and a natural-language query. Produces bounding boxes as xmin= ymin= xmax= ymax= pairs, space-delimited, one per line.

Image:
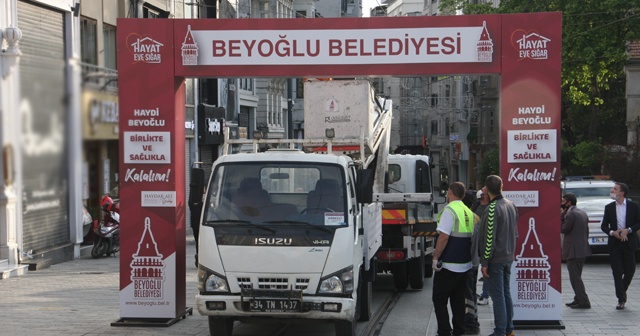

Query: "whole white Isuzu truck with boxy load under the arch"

xmin=190 ymin=80 xmax=391 ymax=336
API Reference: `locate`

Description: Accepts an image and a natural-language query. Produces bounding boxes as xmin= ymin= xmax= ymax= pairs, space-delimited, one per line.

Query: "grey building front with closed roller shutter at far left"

xmin=0 ymin=0 xmax=82 ymax=276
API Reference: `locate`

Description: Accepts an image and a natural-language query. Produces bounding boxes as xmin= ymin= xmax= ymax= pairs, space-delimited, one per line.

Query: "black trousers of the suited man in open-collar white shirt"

xmin=609 ymin=241 xmax=636 ymax=302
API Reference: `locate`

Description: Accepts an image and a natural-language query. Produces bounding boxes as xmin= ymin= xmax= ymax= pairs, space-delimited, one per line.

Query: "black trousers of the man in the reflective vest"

xmin=431 ymin=268 xmax=467 ymax=335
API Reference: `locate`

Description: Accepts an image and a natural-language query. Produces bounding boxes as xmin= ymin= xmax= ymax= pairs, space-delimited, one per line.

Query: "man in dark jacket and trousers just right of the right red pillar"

xmin=560 ymin=194 xmax=591 ymax=309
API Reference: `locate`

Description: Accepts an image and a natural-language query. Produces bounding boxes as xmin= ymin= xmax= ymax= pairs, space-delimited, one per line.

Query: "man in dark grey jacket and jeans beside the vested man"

xmin=480 ymin=175 xmax=518 ymax=336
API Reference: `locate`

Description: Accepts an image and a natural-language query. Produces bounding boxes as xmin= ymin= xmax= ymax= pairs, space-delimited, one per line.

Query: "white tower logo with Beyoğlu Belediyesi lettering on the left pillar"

xmin=130 ymin=217 xmax=164 ymax=300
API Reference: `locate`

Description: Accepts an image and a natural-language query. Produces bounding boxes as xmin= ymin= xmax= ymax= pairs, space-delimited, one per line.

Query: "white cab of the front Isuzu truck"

xmin=196 ymin=151 xmax=377 ymax=335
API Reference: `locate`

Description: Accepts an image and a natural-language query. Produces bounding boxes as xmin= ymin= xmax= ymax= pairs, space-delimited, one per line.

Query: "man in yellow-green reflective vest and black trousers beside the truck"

xmin=432 ymin=182 xmax=476 ymax=336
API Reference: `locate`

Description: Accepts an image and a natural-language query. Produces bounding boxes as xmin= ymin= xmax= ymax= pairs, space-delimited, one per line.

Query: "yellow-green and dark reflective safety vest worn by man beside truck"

xmin=438 ymin=201 xmax=475 ymax=266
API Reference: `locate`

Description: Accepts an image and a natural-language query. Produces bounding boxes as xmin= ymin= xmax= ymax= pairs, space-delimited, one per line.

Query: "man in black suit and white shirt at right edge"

xmin=600 ymin=182 xmax=640 ymax=310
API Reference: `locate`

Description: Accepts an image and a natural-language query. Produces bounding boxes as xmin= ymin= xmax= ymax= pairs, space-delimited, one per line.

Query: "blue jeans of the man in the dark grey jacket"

xmin=484 ymin=261 xmax=513 ymax=335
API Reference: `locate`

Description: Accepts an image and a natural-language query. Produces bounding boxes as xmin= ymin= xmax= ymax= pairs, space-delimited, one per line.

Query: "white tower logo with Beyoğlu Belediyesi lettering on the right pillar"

xmin=515 ymin=217 xmax=551 ymax=302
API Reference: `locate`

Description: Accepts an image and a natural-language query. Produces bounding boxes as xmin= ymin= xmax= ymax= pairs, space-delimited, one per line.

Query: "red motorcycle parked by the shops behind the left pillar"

xmin=91 ymin=196 xmax=120 ymax=259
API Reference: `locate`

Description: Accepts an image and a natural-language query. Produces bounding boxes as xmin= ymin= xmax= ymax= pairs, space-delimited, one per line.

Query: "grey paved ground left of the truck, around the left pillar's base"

xmin=0 ymin=230 xmax=209 ymax=336
